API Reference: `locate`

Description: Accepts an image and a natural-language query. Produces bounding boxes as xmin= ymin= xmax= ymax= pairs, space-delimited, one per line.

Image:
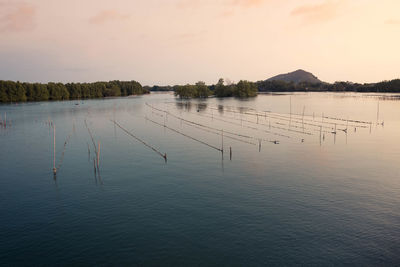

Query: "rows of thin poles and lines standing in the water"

xmin=47 ymin=97 xmax=384 ymax=177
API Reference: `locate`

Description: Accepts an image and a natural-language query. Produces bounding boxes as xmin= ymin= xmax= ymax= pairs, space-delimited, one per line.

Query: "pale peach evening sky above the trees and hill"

xmin=0 ymin=0 xmax=400 ymax=85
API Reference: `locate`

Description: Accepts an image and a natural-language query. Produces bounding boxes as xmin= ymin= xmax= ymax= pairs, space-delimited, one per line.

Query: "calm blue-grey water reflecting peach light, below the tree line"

xmin=0 ymin=93 xmax=400 ymax=266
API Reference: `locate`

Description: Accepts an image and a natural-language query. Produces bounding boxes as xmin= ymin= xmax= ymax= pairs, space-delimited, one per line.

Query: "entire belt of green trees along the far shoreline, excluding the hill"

xmin=0 ymin=75 xmax=400 ymax=103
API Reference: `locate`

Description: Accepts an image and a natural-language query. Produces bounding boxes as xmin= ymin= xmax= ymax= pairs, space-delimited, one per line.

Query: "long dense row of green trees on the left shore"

xmin=0 ymin=81 xmax=149 ymax=103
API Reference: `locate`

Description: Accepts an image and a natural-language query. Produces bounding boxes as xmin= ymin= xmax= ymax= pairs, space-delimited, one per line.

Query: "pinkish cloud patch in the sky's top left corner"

xmin=0 ymin=2 xmax=36 ymax=32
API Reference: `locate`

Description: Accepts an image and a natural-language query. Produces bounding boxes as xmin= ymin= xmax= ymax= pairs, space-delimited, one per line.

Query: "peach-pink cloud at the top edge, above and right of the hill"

xmin=290 ymin=0 xmax=344 ymax=23
